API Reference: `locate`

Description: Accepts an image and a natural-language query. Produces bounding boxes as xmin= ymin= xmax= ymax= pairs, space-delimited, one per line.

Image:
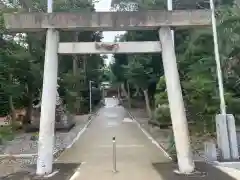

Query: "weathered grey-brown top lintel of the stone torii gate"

xmin=4 ymin=10 xmax=211 ymax=32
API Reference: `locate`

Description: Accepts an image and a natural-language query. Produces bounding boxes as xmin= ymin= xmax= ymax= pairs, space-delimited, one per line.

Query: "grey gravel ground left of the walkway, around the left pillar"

xmin=0 ymin=115 xmax=89 ymax=179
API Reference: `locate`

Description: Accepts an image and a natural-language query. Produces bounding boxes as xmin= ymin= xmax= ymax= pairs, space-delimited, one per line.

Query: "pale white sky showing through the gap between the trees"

xmin=95 ymin=0 xmax=124 ymax=64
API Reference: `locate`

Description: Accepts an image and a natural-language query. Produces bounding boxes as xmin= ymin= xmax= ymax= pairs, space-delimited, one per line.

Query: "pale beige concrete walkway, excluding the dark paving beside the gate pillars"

xmin=58 ymin=98 xmax=170 ymax=180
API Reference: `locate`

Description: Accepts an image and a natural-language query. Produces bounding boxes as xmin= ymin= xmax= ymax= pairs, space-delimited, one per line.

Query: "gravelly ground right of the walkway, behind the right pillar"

xmin=129 ymin=109 xmax=206 ymax=161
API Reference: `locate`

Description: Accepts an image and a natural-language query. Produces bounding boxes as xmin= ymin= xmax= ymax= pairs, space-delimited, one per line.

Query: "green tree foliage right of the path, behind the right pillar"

xmin=111 ymin=0 xmax=240 ymax=131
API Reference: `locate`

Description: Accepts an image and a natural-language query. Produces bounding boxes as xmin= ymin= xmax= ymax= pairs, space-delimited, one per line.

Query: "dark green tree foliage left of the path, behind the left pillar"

xmin=0 ymin=0 xmax=104 ymax=122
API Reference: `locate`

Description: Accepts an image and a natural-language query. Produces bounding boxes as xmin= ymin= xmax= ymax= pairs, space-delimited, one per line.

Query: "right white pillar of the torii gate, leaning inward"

xmin=159 ymin=27 xmax=195 ymax=174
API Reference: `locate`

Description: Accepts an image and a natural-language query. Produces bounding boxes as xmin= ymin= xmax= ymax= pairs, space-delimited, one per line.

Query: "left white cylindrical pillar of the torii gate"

xmin=36 ymin=29 xmax=59 ymax=176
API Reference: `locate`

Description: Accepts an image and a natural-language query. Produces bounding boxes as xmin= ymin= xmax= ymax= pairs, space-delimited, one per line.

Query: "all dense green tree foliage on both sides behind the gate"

xmin=0 ymin=0 xmax=240 ymax=137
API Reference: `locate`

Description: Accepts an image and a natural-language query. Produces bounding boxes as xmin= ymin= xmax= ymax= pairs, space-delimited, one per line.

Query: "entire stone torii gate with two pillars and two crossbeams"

xmin=4 ymin=10 xmax=211 ymax=175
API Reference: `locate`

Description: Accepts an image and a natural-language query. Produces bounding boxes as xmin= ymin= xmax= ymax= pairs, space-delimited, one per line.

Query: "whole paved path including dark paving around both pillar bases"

xmin=3 ymin=99 xmax=240 ymax=180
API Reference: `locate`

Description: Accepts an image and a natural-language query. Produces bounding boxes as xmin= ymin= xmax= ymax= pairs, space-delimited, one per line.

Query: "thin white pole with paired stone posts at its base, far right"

xmin=210 ymin=0 xmax=236 ymax=162
